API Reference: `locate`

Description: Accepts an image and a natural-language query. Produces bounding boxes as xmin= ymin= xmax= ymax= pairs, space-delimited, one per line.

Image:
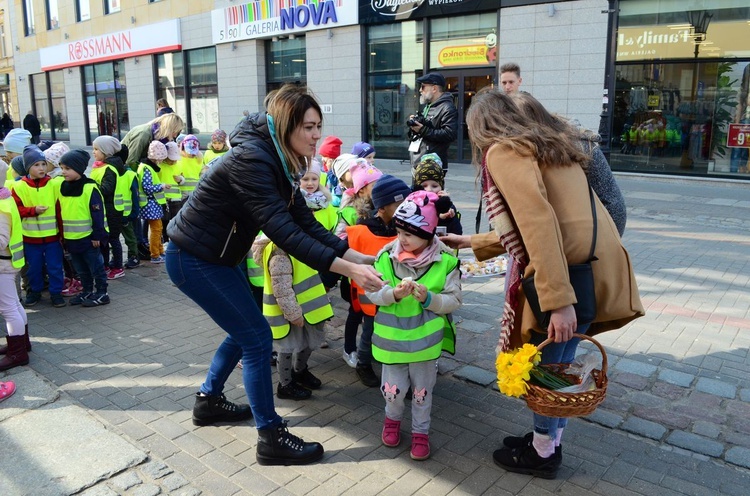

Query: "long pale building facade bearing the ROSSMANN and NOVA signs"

xmin=7 ymin=0 xmax=612 ymax=167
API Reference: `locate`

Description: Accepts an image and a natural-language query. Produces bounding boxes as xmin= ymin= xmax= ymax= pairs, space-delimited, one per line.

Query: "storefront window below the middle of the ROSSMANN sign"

xmin=83 ymin=60 xmax=130 ymax=144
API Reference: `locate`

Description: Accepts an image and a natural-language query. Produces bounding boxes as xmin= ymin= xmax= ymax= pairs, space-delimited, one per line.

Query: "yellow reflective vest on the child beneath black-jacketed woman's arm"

xmin=263 ymin=243 xmax=333 ymax=339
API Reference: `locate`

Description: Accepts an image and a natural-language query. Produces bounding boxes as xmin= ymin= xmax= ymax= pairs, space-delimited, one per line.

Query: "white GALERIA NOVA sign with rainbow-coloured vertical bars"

xmin=211 ymin=0 xmax=358 ymax=44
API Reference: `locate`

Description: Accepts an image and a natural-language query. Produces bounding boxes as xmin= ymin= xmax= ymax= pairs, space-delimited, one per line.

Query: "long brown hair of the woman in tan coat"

xmin=466 ymin=87 xmax=588 ymax=167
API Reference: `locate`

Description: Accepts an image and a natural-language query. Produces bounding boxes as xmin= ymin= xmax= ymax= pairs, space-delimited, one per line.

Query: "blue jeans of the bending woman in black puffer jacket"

xmin=166 ymin=243 xmax=282 ymax=429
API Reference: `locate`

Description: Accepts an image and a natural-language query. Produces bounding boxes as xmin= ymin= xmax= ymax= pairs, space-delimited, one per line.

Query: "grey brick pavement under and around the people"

xmin=0 ymin=162 xmax=750 ymax=496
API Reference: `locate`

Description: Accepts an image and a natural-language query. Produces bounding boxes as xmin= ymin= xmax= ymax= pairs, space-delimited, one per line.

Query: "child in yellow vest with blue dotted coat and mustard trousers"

xmin=138 ymin=141 xmax=172 ymax=264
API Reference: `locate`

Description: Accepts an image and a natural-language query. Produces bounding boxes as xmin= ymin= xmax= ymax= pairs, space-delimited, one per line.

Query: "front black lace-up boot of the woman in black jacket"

xmin=256 ymin=422 xmax=323 ymax=465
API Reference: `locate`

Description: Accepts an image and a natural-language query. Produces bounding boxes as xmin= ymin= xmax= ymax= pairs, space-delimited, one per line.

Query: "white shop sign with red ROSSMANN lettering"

xmin=39 ymin=19 xmax=182 ymax=71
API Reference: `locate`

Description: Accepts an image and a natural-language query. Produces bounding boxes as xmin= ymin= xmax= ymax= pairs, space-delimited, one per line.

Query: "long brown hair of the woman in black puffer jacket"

xmin=264 ymin=84 xmax=323 ymax=173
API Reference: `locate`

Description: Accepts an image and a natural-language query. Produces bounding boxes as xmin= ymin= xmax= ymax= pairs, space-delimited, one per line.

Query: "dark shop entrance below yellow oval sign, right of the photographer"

xmin=442 ymin=67 xmax=495 ymax=162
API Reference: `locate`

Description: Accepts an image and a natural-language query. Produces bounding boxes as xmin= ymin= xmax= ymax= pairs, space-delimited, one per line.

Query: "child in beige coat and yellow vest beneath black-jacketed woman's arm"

xmin=252 ymin=236 xmax=333 ymax=400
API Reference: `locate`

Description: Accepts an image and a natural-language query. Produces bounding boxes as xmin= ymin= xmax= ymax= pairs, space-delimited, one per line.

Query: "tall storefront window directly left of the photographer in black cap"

xmin=366 ymin=21 xmax=424 ymax=157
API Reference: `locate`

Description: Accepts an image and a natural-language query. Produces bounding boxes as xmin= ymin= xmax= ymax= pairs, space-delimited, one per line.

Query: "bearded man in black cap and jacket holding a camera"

xmin=406 ymin=72 xmax=458 ymax=182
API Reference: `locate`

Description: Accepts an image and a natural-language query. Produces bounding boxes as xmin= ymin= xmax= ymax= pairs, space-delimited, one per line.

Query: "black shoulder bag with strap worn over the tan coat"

xmin=521 ymin=187 xmax=599 ymax=330
